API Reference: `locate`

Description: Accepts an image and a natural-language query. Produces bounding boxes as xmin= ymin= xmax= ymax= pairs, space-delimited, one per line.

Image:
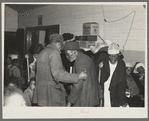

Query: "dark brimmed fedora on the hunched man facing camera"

xmin=63 ymin=42 xmax=81 ymax=50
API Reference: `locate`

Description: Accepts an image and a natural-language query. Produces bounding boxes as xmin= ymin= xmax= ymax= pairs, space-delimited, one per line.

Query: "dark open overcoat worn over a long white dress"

xmin=100 ymin=57 xmax=126 ymax=107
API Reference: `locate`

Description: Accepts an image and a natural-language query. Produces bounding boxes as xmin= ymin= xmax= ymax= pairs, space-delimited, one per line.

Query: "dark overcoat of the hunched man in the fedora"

xmin=68 ymin=51 xmax=99 ymax=107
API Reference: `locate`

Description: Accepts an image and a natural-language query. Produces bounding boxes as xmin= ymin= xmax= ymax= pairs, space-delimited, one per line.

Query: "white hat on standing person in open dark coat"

xmin=108 ymin=43 xmax=120 ymax=54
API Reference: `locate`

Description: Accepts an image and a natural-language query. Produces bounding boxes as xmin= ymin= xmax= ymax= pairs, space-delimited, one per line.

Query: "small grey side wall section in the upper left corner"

xmin=5 ymin=6 xmax=18 ymax=32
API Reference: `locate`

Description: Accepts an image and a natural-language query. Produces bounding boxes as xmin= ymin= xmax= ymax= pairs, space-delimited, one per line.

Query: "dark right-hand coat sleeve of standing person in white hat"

xmin=118 ymin=63 xmax=127 ymax=106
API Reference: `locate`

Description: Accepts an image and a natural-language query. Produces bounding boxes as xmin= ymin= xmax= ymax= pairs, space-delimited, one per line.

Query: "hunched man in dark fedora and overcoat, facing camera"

xmin=64 ymin=42 xmax=99 ymax=107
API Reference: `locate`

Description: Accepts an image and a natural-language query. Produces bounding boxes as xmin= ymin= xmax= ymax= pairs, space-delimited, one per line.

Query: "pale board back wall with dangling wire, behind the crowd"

xmin=19 ymin=5 xmax=146 ymax=63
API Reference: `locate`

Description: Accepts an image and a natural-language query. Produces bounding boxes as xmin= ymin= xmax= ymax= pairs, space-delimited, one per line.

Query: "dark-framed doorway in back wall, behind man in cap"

xmin=24 ymin=25 xmax=60 ymax=53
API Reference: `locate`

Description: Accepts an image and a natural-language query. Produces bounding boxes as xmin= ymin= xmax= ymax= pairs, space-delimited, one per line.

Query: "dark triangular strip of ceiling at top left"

xmin=5 ymin=4 xmax=46 ymax=13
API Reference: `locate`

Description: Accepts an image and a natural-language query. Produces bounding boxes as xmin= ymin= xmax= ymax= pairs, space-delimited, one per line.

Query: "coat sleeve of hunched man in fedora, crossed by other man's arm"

xmin=68 ymin=62 xmax=86 ymax=104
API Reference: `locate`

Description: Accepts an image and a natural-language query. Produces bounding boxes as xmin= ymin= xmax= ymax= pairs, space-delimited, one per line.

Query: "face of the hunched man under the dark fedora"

xmin=65 ymin=50 xmax=77 ymax=62
